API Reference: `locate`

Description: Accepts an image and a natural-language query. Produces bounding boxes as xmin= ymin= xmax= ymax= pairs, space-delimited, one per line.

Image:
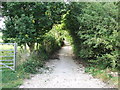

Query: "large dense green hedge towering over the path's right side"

xmin=64 ymin=3 xmax=120 ymax=68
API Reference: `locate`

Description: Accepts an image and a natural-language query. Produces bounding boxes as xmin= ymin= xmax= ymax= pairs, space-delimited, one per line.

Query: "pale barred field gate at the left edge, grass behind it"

xmin=0 ymin=43 xmax=17 ymax=71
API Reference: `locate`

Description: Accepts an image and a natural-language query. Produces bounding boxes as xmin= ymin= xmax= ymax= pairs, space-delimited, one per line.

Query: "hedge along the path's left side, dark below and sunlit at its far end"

xmin=21 ymin=25 xmax=63 ymax=73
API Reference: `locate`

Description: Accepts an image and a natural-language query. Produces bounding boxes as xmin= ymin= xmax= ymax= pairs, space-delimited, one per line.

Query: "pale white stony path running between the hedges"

xmin=20 ymin=46 xmax=109 ymax=88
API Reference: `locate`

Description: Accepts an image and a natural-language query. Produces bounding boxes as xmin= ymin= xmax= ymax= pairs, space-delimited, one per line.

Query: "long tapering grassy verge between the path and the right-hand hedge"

xmin=74 ymin=57 xmax=120 ymax=88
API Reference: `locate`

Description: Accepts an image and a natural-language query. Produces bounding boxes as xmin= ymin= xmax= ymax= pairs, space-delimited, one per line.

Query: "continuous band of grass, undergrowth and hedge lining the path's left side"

xmin=2 ymin=24 xmax=63 ymax=88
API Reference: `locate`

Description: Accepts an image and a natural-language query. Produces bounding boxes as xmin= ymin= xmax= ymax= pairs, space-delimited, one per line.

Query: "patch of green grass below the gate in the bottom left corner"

xmin=1 ymin=69 xmax=29 ymax=88
